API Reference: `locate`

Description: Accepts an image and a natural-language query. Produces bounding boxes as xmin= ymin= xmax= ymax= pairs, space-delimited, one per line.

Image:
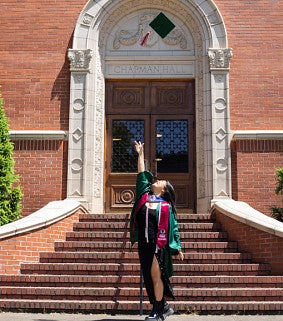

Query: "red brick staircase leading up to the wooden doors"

xmin=0 ymin=214 xmax=283 ymax=314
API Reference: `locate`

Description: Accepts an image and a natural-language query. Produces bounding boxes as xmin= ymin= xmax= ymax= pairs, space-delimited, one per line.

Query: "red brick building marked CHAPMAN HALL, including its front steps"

xmin=0 ymin=0 xmax=283 ymax=313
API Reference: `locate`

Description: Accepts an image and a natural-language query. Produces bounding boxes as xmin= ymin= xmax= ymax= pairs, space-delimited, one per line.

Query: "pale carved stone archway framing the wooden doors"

xmin=67 ymin=0 xmax=232 ymax=212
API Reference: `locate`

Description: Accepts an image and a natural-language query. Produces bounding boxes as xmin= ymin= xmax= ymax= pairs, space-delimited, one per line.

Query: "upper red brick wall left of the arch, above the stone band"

xmin=0 ymin=0 xmax=87 ymax=130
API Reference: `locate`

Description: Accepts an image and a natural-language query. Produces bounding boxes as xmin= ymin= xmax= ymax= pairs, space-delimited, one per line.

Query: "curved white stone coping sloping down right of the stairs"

xmin=212 ymin=199 xmax=283 ymax=237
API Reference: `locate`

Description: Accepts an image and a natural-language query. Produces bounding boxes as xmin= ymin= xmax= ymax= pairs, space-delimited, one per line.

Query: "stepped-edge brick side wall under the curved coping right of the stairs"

xmin=214 ymin=210 xmax=283 ymax=275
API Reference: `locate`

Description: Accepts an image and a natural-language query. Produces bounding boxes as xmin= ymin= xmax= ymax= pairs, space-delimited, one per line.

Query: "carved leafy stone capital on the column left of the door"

xmin=68 ymin=49 xmax=92 ymax=71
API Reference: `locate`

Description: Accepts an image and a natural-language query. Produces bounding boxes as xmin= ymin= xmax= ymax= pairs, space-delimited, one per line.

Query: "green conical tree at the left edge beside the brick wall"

xmin=0 ymin=94 xmax=22 ymax=226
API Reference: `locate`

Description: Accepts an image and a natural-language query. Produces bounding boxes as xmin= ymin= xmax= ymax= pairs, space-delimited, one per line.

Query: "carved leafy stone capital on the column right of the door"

xmin=208 ymin=48 xmax=233 ymax=70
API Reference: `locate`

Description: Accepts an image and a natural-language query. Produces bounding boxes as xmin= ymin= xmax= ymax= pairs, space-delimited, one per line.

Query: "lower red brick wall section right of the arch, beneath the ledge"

xmin=231 ymin=140 xmax=283 ymax=216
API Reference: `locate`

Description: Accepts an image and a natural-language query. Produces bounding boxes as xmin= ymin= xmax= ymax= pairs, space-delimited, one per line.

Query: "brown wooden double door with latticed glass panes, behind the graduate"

xmin=105 ymin=80 xmax=195 ymax=212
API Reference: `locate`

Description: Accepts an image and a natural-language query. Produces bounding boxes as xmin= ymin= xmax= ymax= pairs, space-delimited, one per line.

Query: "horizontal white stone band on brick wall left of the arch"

xmin=9 ymin=130 xmax=68 ymax=141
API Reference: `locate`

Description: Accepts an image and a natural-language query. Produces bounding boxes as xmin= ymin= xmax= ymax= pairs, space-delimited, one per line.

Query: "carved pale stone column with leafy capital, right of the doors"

xmin=208 ymin=48 xmax=232 ymax=199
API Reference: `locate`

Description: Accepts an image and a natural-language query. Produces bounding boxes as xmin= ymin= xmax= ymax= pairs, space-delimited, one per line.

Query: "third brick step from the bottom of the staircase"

xmin=0 ymin=275 xmax=283 ymax=288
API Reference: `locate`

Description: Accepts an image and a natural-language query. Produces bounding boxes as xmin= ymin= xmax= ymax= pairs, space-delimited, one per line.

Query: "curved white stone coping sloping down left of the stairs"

xmin=0 ymin=199 xmax=88 ymax=239
